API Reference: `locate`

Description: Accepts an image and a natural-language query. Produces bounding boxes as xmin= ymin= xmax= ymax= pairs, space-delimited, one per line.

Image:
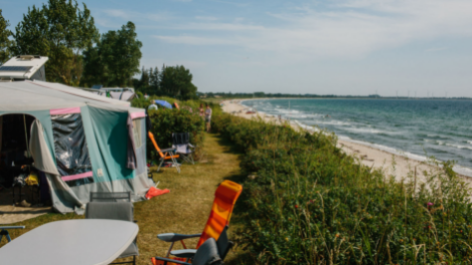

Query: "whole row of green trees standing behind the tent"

xmin=0 ymin=0 xmax=197 ymax=99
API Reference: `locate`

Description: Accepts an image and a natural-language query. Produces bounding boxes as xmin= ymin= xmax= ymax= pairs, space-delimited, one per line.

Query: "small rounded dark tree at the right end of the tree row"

xmin=160 ymin=66 xmax=197 ymax=100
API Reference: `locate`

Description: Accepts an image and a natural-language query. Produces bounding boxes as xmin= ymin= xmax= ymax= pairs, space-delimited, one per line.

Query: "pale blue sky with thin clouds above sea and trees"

xmin=0 ymin=0 xmax=472 ymax=97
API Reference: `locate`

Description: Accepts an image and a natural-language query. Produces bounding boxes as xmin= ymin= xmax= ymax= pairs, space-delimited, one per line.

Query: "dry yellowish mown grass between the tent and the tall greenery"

xmin=0 ymin=134 xmax=244 ymax=265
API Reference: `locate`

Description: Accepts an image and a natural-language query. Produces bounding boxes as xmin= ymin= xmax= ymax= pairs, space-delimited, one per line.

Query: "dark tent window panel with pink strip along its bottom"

xmin=51 ymin=113 xmax=93 ymax=187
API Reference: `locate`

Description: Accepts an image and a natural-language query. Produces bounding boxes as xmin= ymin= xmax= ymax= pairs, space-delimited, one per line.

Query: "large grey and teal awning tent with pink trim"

xmin=0 ymin=81 xmax=153 ymax=213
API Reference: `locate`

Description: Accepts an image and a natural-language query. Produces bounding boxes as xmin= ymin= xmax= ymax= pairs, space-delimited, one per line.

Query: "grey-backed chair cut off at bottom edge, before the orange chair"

xmin=151 ymin=238 xmax=223 ymax=265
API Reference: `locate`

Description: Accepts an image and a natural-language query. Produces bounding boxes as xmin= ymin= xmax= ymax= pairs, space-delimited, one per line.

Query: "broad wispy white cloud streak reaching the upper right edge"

xmin=158 ymin=0 xmax=472 ymax=58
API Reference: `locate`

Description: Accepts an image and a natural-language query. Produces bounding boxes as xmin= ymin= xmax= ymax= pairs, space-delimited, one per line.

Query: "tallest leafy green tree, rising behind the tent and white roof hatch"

xmin=12 ymin=0 xmax=99 ymax=85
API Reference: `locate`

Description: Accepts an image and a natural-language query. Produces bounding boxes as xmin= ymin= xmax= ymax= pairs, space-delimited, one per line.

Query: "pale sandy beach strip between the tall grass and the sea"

xmin=222 ymin=100 xmax=472 ymax=187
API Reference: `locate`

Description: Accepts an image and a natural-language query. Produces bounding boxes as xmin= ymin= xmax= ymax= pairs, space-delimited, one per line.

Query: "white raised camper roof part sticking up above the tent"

xmin=0 ymin=55 xmax=48 ymax=81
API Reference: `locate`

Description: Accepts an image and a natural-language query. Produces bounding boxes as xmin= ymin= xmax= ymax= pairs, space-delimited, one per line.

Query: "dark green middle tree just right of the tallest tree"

xmin=84 ymin=21 xmax=143 ymax=87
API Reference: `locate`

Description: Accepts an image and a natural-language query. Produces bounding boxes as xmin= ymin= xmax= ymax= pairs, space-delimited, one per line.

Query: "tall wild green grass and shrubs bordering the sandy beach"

xmin=213 ymin=114 xmax=472 ymax=264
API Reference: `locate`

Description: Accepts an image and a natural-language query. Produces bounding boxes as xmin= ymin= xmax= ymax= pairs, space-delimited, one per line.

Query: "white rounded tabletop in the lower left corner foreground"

xmin=0 ymin=219 xmax=139 ymax=265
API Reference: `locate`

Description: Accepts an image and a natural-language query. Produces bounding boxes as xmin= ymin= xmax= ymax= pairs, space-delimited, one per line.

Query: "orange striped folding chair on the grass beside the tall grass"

xmin=157 ymin=180 xmax=243 ymax=258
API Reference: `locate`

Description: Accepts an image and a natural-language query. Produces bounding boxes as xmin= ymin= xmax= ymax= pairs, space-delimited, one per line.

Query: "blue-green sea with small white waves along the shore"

xmin=242 ymin=99 xmax=472 ymax=176
